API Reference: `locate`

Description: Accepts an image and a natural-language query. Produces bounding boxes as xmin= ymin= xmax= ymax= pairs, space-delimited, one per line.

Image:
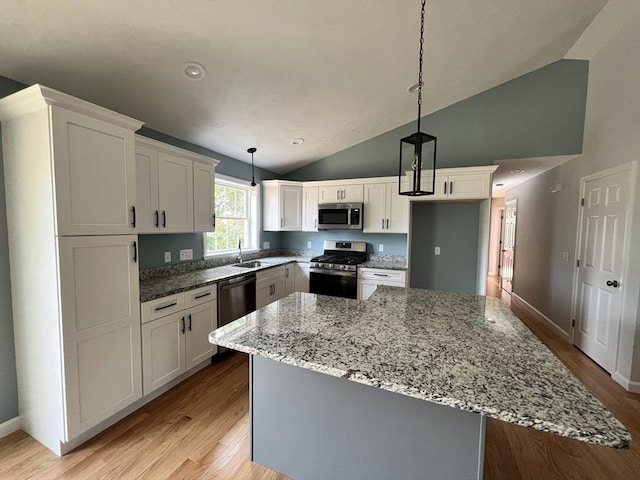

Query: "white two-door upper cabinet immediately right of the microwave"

xmin=362 ymin=182 xmax=409 ymax=233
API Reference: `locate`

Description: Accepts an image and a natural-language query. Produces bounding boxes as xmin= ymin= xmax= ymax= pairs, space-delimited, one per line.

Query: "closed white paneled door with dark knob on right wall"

xmin=574 ymin=169 xmax=629 ymax=372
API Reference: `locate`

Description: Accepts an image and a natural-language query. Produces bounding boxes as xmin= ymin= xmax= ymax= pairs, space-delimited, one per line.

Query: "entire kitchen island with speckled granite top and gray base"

xmin=209 ymin=287 xmax=630 ymax=478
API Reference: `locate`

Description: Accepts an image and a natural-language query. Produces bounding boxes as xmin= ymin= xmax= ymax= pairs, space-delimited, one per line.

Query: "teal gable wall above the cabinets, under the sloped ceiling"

xmin=286 ymin=60 xmax=589 ymax=180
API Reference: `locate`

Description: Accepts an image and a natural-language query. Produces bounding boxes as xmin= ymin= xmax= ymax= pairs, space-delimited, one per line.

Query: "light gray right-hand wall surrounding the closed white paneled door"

xmin=507 ymin=18 xmax=640 ymax=387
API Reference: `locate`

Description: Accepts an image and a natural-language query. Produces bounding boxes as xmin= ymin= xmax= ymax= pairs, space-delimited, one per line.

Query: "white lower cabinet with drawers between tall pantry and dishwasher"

xmin=142 ymin=285 xmax=218 ymax=395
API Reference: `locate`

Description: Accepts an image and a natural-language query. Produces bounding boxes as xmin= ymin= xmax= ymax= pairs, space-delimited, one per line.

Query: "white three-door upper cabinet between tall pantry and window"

xmin=136 ymin=136 xmax=218 ymax=233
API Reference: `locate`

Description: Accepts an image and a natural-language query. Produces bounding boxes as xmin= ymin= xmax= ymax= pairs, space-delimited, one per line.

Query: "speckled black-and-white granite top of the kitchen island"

xmin=209 ymin=287 xmax=631 ymax=448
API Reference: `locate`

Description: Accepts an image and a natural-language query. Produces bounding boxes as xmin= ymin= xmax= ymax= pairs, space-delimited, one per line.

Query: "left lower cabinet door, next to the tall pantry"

xmin=142 ymin=312 xmax=186 ymax=395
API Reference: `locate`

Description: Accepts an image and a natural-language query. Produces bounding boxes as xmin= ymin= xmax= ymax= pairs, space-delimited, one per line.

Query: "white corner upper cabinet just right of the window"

xmin=262 ymin=180 xmax=302 ymax=232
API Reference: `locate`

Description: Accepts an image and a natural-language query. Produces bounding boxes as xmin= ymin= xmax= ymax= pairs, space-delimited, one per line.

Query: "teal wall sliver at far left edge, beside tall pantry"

xmin=0 ymin=76 xmax=27 ymax=423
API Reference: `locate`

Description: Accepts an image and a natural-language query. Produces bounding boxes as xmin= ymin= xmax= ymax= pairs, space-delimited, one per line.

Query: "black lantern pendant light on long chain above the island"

xmin=398 ymin=0 xmax=437 ymax=197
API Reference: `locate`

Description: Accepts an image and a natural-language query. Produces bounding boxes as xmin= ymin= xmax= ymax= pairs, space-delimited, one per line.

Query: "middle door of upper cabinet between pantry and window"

xmin=158 ymin=152 xmax=193 ymax=233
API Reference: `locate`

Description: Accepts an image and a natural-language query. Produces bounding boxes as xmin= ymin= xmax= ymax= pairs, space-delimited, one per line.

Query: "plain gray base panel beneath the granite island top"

xmin=250 ymin=355 xmax=485 ymax=480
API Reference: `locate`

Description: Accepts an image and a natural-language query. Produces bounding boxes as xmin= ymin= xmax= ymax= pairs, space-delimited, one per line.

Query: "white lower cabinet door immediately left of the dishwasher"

xmin=185 ymin=302 xmax=218 ymax=370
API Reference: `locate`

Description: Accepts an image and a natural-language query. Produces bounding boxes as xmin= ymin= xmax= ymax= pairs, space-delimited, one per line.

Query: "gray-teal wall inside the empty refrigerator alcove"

xmin=409 ymin=202 xmax=480 ymax=294
